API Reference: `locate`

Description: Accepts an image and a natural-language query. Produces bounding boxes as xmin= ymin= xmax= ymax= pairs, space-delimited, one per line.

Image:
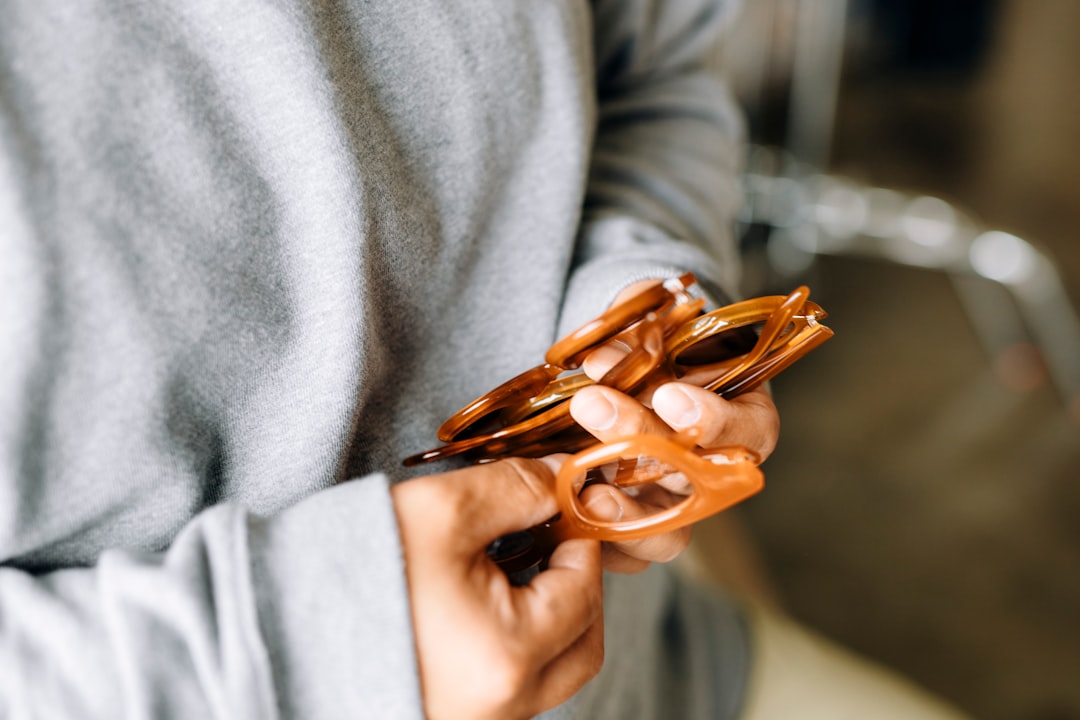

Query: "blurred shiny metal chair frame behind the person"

xmin=735 ymin=0 xmax=1080 ymax=422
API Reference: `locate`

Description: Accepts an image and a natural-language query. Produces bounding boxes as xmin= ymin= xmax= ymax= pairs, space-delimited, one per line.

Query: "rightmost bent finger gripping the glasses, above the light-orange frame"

xmin=652 ymin=382 xmax=780 ymax=459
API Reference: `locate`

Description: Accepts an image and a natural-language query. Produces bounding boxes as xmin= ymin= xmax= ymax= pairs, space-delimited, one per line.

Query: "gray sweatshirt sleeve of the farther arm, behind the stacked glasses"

xmin=561 ymin=0 xmax=743 ymax=330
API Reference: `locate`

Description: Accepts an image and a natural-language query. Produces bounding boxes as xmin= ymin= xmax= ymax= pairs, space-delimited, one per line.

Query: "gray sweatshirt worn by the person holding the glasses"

xmin=0 ymin=0 xmax=743 ymax=719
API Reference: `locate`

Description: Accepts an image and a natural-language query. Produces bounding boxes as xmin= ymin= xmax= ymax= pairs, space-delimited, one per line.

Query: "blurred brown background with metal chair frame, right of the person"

xmin=694 ymin=0 xmax=1080 ymax=720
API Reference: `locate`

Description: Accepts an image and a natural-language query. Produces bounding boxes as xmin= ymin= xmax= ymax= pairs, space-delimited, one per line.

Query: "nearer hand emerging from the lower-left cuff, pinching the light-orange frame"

xmin=392 ymin=459 xmax=604 ymax=720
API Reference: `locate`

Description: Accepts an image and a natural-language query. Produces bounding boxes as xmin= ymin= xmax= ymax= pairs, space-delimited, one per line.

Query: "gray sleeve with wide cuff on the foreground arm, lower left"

xmin=0 ymin=476 xmax=422 ymax=720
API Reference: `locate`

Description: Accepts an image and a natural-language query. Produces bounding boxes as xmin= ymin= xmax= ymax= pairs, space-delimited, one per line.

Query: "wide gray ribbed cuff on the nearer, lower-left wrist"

xmin=251 ymin=475 xmax=423 ymax=720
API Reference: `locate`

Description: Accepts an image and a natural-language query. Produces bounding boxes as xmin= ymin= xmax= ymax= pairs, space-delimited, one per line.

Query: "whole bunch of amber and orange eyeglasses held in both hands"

xmin=405 ymin=273 xmax=833 ymax=582
